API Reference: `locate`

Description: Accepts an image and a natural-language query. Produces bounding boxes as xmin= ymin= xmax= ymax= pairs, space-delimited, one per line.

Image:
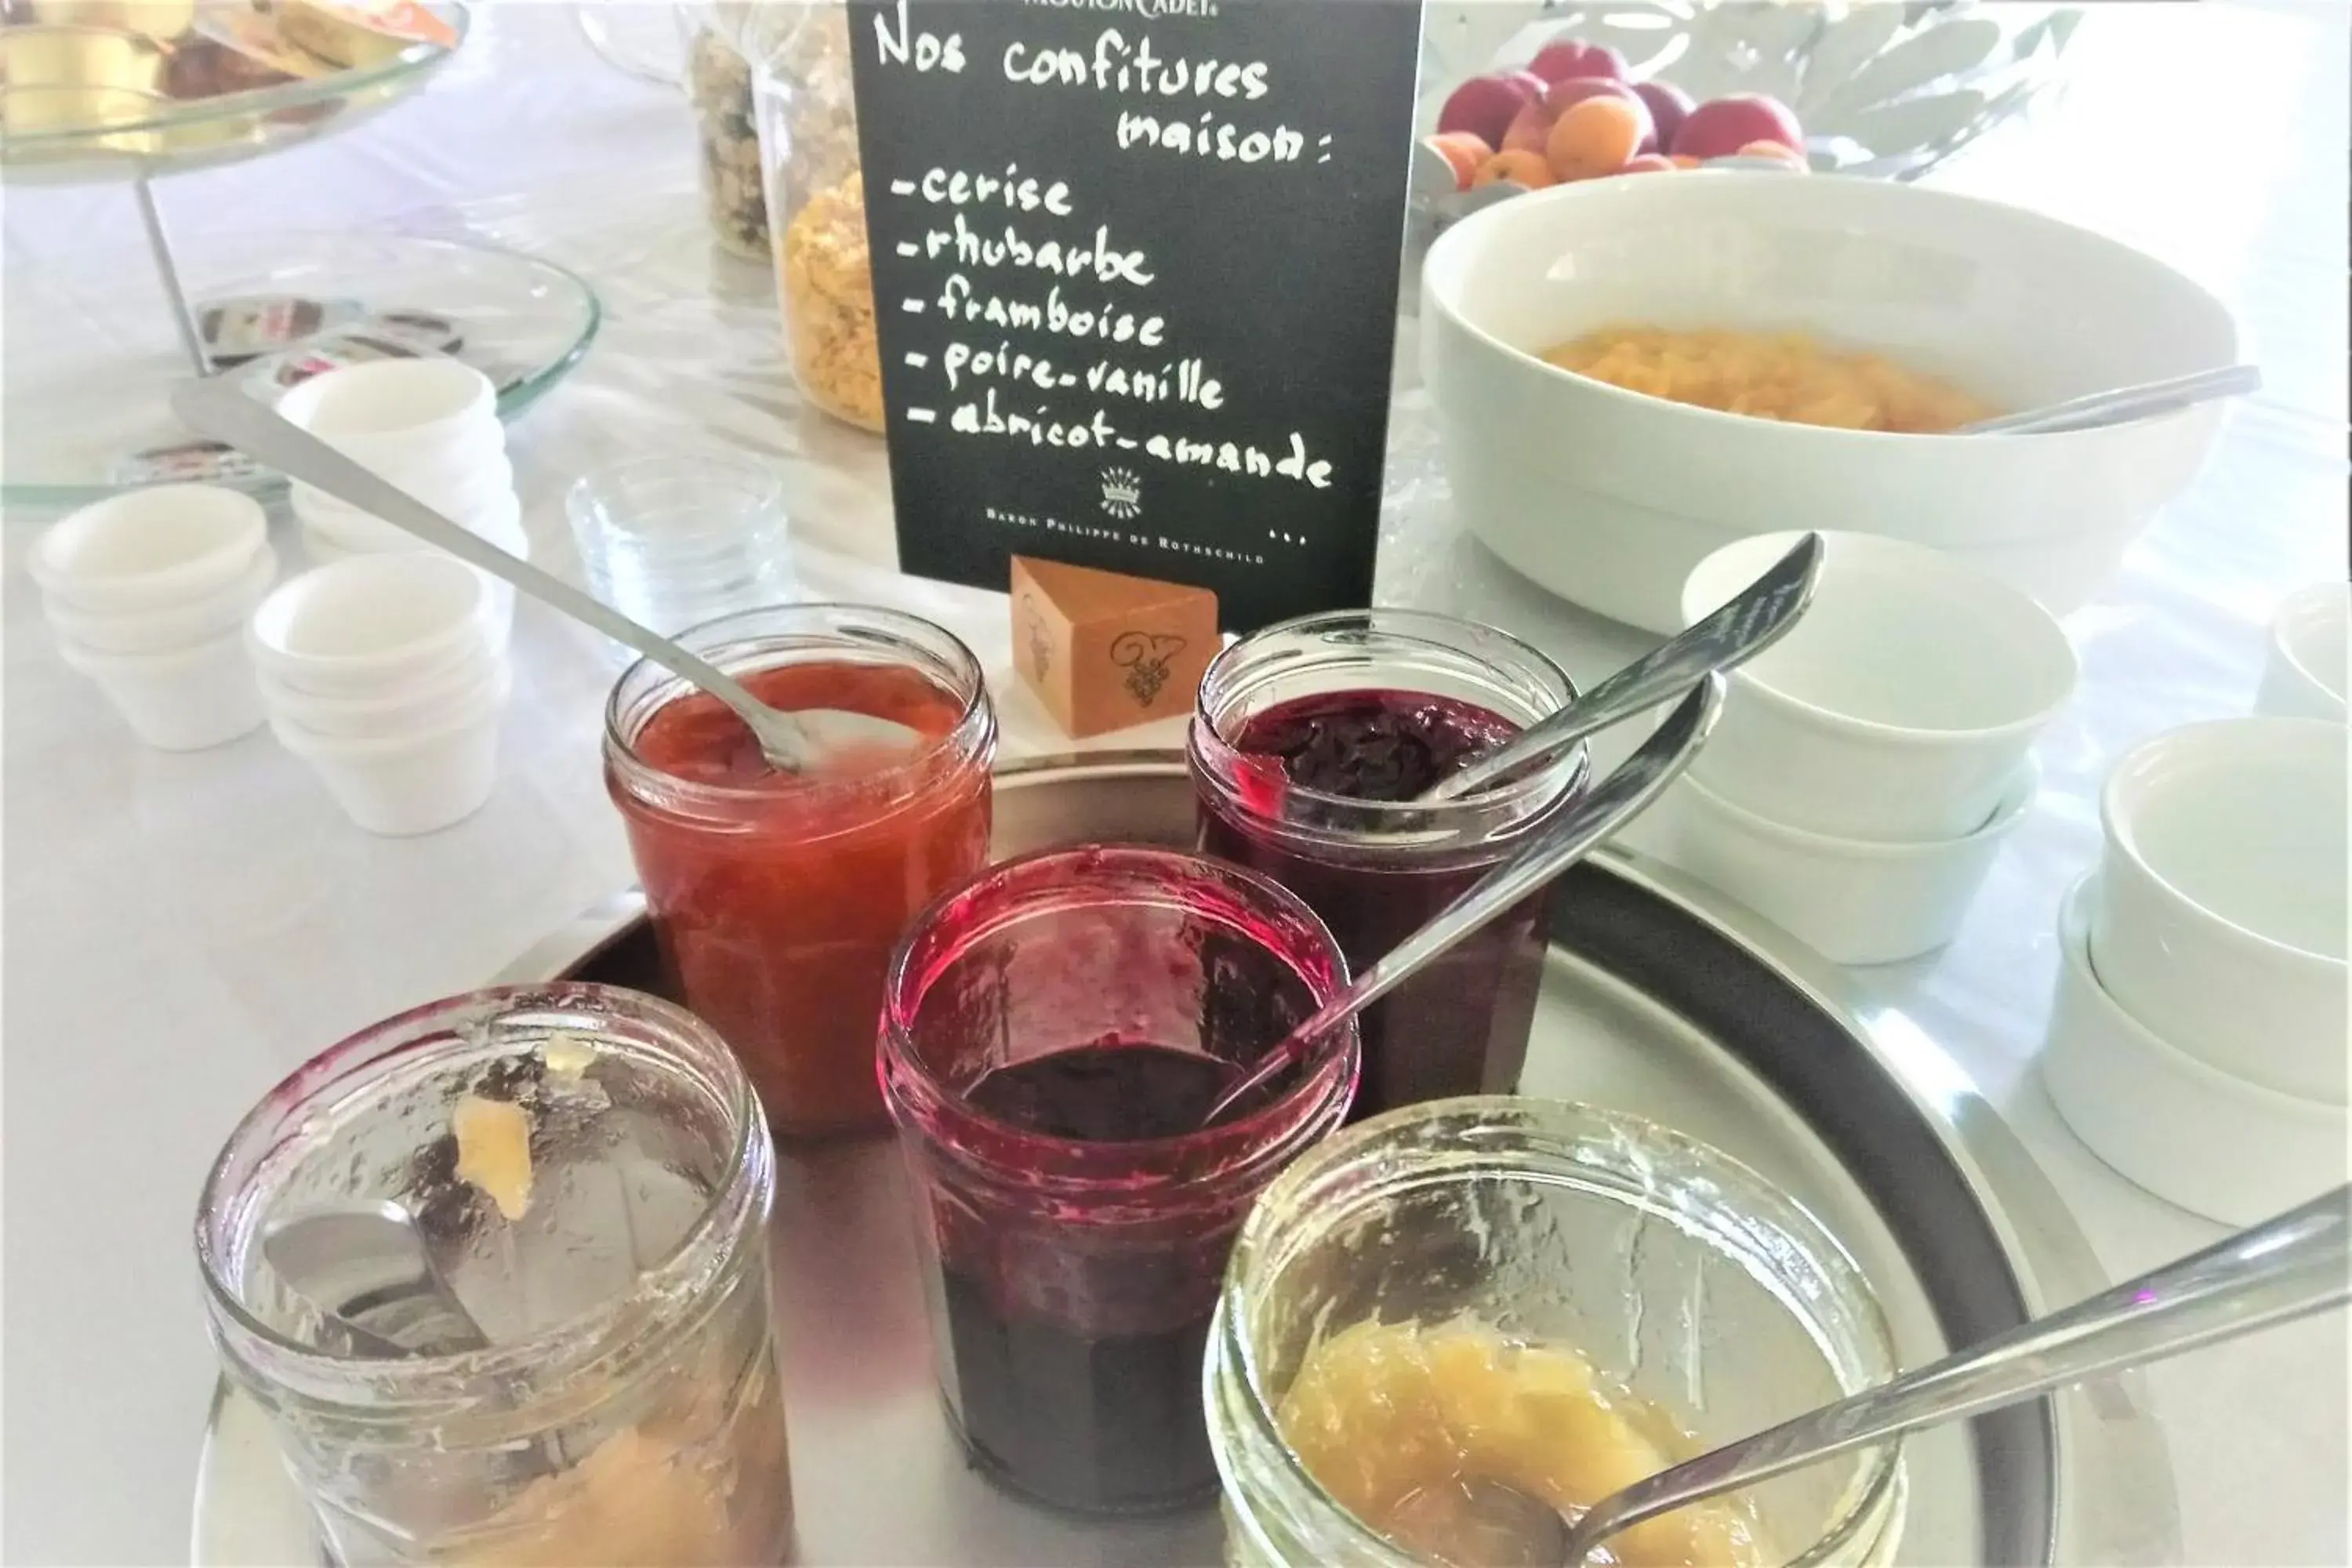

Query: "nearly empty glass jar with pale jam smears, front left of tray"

xmin=195 ymin=985 xmax=793 ymax=1568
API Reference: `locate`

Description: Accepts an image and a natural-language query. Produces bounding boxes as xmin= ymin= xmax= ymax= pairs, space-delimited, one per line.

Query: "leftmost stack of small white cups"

xmin=31 ymin=485 xmax=278 ymax=753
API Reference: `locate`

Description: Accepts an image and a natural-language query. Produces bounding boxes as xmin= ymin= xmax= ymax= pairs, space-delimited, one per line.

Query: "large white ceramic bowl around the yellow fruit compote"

xmin=1421 ymin=169 xmax=2239 ymax=633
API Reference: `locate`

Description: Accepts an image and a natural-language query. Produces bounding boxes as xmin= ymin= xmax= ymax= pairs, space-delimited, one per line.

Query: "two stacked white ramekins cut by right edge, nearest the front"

xmin=2042 ymin=717 xmax=2352 ymax=1225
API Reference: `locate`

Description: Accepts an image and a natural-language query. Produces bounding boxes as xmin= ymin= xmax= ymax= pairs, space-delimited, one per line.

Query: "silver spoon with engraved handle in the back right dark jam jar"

xmin=1414 ymin=534 xmax=1825 ymax=804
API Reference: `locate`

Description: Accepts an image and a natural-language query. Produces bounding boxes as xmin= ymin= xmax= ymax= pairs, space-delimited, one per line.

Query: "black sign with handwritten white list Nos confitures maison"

xmin=849 ymin=0 xmax=1421 ymax=630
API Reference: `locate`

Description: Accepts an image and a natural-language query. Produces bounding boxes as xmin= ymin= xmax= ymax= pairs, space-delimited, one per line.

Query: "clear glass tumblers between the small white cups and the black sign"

xmin=564 ymin=454 xmax=797 ymax=637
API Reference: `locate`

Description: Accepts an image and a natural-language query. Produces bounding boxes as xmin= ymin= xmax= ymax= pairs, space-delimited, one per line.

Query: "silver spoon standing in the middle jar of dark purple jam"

xmin=1200 ymin=675 xmax=1724 ymax=1126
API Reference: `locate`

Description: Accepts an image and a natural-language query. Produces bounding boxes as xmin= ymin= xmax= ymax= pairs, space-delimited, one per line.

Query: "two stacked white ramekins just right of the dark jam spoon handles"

xmin=1628 ymin=534 xmax=2074 ymax=964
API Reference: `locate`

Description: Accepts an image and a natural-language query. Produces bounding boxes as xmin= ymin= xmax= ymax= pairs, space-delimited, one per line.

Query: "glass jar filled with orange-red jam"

xmin=604 ymin=604 xmax=997 ymax=1135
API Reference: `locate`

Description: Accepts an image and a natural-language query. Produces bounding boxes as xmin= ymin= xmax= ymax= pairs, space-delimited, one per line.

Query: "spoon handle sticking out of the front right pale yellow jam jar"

xmin=1566 ymin=1187 xmax=2352 ymax=1568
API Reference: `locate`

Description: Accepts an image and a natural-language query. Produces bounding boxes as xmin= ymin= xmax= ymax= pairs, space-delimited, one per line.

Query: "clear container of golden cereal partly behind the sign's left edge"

xmin=743 ymin=0 xmax=882 ymax=433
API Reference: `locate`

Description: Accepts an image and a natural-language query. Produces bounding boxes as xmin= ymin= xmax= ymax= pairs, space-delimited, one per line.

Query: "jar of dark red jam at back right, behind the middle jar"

xmin=1185 ymin=609 xmax=1588 ymax=1119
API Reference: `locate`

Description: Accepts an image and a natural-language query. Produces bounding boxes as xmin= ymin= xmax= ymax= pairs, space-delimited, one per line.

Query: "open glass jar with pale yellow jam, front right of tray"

xmin=1207 ymin=1095 xmax=1903 ymax=1568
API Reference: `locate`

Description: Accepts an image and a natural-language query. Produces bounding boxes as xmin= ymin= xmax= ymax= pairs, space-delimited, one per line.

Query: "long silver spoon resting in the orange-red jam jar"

xmin=172 ymin=379 xmax=920 ymax=774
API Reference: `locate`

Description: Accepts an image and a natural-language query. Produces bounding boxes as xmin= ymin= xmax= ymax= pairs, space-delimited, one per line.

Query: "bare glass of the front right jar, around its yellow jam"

xmin=1207 ymin=1095 xmax=1903 ymax=1568
